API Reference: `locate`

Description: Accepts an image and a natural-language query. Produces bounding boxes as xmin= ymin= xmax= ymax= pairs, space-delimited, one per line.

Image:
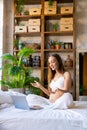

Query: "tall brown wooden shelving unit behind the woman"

xmin=13 ymin=0 xmax=76 ymax=98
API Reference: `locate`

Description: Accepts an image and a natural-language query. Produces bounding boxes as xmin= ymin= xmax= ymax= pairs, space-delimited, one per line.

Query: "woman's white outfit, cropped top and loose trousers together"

xmin=27 ymin=77 xmax=74 ymax=109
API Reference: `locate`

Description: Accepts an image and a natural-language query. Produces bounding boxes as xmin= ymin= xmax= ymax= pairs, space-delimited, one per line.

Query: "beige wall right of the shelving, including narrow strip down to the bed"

xmin=75 ymin=0 xmax=87 ymax=100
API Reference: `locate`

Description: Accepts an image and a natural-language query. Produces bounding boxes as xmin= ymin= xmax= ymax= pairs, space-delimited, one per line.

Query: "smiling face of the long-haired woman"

xmin=48 ymin=56 xmax=58 ymax=70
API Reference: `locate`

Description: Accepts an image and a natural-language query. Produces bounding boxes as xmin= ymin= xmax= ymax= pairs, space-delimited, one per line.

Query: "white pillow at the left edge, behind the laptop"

xmin=0 ymin=90 xmax=13 ymax=104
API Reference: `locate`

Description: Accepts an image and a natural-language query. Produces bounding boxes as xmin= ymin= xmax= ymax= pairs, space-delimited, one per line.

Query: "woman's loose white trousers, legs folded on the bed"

xmin=26 ymin=93 xmax=74 ymax=109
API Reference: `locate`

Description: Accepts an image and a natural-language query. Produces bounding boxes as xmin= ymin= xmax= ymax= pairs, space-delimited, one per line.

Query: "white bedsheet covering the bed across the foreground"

xmin=0 ymin=101 xmax=87 ymax=130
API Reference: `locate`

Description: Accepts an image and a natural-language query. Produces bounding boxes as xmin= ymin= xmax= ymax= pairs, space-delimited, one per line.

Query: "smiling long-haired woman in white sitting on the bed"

xmin=29 ymin=54 xmax=73 ymax=109
